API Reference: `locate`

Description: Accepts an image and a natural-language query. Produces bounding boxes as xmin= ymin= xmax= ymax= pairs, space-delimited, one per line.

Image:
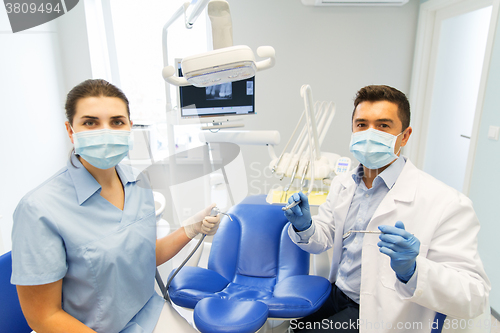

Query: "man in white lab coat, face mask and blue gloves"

xmin=285 ymin=86 xmax=490 ymax=332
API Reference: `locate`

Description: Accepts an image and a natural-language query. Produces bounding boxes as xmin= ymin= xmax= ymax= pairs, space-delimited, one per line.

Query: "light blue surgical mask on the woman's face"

xmin=71 ymin=128 xmax=132 ymax=169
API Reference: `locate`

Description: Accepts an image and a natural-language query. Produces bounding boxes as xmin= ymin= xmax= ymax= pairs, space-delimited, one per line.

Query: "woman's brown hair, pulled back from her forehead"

xmin=65 ymin=79 xmax=130 ymax=125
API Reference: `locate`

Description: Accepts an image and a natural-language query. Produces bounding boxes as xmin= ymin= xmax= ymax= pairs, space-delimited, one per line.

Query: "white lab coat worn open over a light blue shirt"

xmin=289 ymin=160 xmax=491 ymax=332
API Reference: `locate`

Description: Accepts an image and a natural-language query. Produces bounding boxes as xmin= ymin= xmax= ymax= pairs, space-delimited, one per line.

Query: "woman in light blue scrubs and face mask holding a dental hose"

xmin=11 ymin=80 xmax=220 ymax=333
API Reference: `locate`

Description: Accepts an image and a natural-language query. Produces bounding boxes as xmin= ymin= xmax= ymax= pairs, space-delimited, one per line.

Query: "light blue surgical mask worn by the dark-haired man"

xmin=349 ymin=128 xmax=403 ymax=170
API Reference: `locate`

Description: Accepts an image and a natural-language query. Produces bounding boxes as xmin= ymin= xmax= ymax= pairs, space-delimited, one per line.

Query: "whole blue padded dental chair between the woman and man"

xmin=168 ymin=195 xmax=331 ymax=333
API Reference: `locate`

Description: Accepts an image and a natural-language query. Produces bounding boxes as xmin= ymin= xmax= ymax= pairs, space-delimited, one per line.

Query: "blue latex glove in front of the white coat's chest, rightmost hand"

xmin=377 ymin=221 xmax=420 ymax=283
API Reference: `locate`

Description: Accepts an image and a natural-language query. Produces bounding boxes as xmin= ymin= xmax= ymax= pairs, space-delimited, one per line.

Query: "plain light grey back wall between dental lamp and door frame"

xmin=229 ymin=0 xmax=420 ymax=194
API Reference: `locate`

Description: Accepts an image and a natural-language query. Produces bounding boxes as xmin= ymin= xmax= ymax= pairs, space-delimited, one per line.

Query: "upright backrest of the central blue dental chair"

xmin=208 ymin=195 xmax=309 ymax=288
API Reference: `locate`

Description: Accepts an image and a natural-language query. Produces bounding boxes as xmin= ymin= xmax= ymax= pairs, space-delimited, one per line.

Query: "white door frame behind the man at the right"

xmin=405 ymin=0 xmax=500 ymax=195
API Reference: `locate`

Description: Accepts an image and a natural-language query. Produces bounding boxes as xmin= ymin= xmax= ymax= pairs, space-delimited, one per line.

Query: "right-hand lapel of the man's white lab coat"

xmin=369 ymin=160 xmax=418 ymax=226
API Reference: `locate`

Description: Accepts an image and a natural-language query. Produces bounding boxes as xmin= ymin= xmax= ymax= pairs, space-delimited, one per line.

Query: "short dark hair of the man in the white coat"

xmin=352 ymin=85 xmax=410 ymax=131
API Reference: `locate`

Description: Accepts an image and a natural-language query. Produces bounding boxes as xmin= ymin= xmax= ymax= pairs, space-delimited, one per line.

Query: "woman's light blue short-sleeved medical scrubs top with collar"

xmin=11 ymin=155 xmax=164 ymax=333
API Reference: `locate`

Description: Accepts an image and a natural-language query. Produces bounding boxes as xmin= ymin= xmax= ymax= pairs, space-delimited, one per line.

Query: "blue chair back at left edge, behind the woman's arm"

xmin=0 ymin=252 xmax=31 ymax=333
